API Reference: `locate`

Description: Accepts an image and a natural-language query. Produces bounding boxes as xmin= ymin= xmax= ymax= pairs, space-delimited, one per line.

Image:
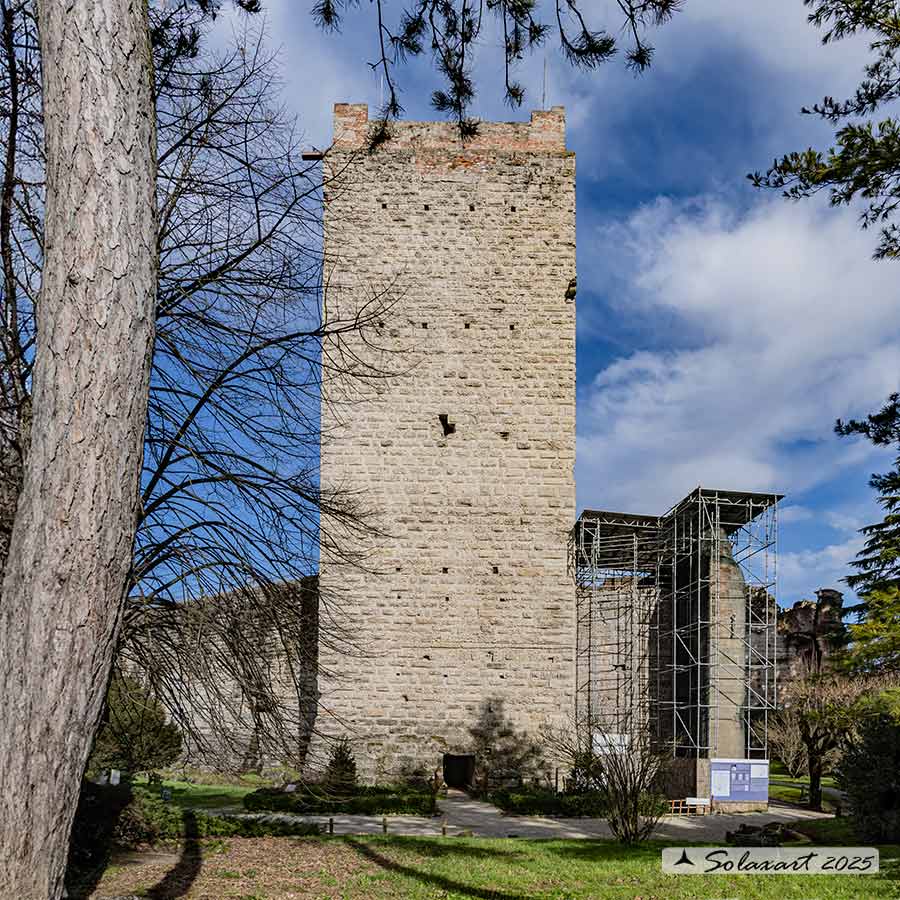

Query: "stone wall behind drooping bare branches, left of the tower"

xmin=132 ymin=577 xmax=318 ymax=773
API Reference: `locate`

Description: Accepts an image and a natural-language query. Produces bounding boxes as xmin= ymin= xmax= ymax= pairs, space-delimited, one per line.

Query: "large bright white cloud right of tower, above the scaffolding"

xmin=578 ymin=198 xmax=900 ymax=512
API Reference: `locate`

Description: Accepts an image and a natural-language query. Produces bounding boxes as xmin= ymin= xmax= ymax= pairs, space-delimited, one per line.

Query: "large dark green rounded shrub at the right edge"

xmin=837 ymin=710 xmax=900 ymax=844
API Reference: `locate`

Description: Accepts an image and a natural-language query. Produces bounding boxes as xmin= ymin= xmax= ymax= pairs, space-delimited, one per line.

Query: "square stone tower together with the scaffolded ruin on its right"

xmin=317 ymin=104 xmax=780 ymax=796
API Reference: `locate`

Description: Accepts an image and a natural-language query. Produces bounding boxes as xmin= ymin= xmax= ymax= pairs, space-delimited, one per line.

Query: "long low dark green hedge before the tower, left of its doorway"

xmin=244 ymin=785 xmax=436 ymax=816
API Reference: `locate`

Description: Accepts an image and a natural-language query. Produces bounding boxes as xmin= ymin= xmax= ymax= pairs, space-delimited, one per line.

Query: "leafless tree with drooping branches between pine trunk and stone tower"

xmin=4 ymin=5 xmax=396 ymax=767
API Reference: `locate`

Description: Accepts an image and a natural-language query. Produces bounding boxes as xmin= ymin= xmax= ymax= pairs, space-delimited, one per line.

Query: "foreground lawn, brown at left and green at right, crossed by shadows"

xmin=84 ymin=836 xmax=900 ymax=900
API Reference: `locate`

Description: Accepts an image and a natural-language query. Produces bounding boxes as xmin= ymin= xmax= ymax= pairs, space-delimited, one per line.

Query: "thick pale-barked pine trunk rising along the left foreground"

xmin=0 ymin=0 xmax=156 ymax=900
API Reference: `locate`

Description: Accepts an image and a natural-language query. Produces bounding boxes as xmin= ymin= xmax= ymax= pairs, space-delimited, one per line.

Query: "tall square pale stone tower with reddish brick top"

xmin=317 ymin=104 xmax=575 ymax=778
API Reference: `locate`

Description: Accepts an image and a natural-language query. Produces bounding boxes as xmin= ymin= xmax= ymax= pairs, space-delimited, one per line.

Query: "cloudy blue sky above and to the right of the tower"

xmin=214 ymin=0 xmax=900 ymax=603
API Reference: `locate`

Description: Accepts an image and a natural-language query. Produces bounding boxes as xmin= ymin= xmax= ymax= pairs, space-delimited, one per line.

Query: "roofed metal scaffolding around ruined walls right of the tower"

xmin=569 ymin=488 xmax=781 ymax=759
